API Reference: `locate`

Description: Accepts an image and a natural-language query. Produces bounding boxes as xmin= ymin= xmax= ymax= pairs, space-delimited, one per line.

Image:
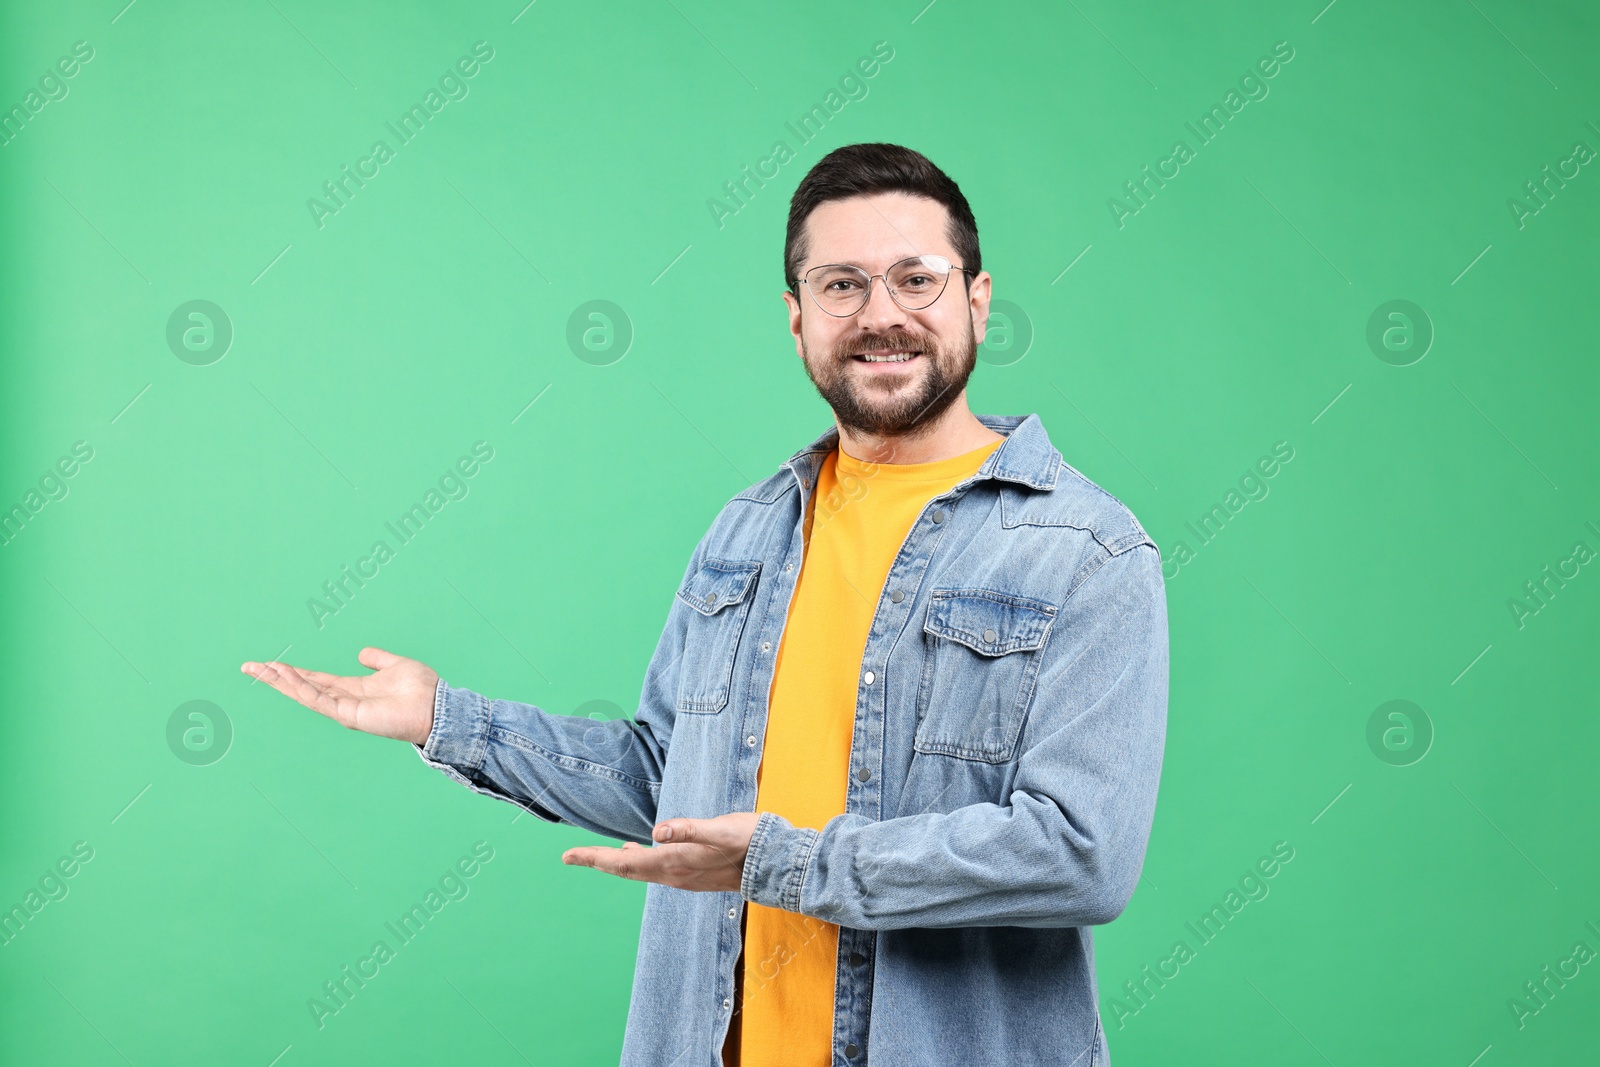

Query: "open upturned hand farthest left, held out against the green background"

xmin=238 ymin=648 xmax=438 ymax=744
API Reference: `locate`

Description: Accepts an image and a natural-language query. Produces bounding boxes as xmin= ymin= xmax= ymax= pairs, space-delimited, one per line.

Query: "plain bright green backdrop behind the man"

xmin=0 ymin=0 xmax=1600 ymax=1067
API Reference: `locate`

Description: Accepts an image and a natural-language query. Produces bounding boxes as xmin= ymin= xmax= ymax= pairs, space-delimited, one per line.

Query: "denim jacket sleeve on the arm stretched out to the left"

xmin=413 ymin=537 xmax=706 ymax=845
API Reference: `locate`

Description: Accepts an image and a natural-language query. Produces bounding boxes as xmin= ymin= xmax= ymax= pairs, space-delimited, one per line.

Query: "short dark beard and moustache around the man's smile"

xmin=800 ymin=322 xmax=978 ymax=438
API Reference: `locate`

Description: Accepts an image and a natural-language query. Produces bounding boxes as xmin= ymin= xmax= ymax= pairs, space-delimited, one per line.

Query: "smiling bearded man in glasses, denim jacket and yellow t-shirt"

xmin=245 ymin=144 xmax=1168 ymax=1067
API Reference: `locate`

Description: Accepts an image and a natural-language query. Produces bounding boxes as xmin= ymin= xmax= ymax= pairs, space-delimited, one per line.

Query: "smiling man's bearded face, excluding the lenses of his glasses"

xmin=784 ymin=192 xmax=989 ymax=437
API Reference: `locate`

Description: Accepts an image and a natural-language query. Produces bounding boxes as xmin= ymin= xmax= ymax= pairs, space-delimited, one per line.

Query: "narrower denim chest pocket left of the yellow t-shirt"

xmin=678 ymin=557 xmax=762 ymax=715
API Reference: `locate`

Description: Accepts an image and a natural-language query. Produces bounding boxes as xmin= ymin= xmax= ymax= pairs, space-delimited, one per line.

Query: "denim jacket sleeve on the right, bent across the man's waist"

xmin=741 ymin=542 xmax=1168 ymax=929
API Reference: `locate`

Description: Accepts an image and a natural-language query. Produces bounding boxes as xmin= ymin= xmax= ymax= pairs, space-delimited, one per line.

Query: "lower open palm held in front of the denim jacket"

xmin=562 ymin=811 xmax=760 ymax=893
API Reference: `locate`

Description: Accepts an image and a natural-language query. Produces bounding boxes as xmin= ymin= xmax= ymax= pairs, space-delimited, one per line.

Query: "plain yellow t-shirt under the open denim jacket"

xmin=725 ymin=438 xmax=1003 ymax=1067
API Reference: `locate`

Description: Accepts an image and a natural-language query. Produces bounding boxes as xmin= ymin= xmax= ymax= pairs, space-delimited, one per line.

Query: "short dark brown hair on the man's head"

xmin=784 ymin=142 xmax=984 ymax=293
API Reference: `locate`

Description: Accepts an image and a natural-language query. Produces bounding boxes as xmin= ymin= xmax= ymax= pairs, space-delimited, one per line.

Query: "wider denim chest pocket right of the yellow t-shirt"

xmin=912 ymin=589 xmax=1056 ymax=763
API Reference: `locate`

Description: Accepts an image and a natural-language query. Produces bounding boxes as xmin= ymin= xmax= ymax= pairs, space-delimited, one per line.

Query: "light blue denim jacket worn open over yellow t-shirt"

xmin=418 ymin=414 xmax=1168 ymax=1067
